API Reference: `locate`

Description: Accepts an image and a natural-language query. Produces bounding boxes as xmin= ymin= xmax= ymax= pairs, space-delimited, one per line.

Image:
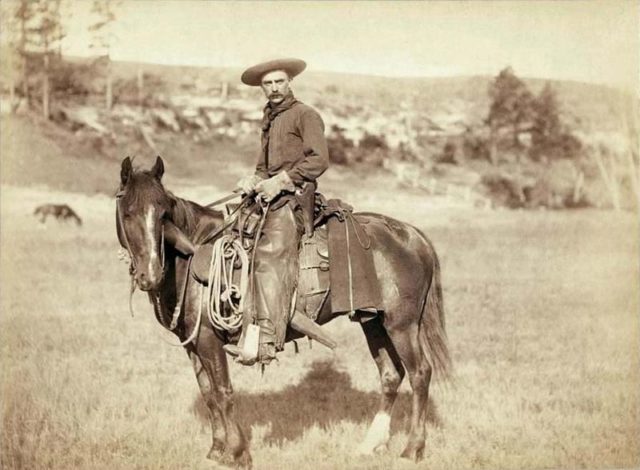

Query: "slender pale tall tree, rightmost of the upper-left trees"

xmin=89 ymin=0 xmax=121 ymax=110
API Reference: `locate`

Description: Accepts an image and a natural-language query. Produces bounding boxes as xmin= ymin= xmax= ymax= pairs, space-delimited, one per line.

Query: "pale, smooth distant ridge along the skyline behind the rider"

xmin=104 ymin=58 xmax=633 ymax=131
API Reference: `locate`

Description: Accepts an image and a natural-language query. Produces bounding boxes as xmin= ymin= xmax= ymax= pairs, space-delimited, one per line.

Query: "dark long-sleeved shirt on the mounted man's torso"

xmin=256 ymin=102 xmax=329 ymax=186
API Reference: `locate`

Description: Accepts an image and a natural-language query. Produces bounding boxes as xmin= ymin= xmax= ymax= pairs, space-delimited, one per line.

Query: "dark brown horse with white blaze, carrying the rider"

xmin=116 ymin=157 xmax=451 ymax=468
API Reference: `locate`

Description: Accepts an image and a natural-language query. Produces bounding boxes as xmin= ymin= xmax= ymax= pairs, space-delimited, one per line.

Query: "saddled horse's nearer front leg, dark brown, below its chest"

xmin=195 ymin=328 xmax=251 ymax=469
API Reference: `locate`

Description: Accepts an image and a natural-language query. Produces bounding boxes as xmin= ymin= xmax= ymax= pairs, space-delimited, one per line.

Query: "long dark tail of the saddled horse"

xmin=418 ymin=239 xmax=451 ymax=379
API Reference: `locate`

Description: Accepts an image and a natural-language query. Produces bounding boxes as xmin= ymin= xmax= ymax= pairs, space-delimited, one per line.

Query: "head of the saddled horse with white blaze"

xmin=117 ymin=157 xmax=171 ymax=291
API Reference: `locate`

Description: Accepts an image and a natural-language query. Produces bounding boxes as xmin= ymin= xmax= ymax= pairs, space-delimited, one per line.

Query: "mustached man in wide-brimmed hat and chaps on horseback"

xmin=225 ymin=59 xmax=329 ymax=364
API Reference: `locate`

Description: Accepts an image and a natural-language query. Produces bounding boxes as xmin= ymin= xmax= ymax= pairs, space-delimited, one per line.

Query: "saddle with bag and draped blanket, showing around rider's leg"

xmin=169 ymin=193 xmax=384 ymax=328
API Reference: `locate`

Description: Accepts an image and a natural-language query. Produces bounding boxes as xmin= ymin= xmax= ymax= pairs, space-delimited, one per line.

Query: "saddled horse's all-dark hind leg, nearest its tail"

xmin=386 ymin=322 xmax=432 ymax=462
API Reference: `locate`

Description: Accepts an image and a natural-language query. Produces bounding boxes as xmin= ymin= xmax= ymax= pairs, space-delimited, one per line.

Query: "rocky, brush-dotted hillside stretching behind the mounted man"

xmin=1 ymin=59 xmax=633 ymax=208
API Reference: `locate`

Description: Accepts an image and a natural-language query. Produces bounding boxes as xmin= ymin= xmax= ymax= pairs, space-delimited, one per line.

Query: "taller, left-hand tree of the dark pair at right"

xmin=487 ymin=67 xmax=533 ymax=163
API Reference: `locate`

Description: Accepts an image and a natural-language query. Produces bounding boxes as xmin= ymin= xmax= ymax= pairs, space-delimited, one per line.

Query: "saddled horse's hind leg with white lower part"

xmin=358 ymin=317 xmax=404 ymax=455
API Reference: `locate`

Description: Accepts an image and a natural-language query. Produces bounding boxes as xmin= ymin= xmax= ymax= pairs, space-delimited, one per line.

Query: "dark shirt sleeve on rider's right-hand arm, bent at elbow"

xmin=287 ymin=108 xmax=329 ymax=185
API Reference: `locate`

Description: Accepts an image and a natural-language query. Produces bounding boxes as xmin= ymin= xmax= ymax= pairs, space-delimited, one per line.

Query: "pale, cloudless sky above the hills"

xmin=57 ymin=0 xmax=640 ymax=91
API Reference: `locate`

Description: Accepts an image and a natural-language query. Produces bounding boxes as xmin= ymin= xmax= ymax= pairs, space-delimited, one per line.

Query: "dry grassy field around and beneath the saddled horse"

xmin=0 ymin=186 xmax=640 ymax=470
